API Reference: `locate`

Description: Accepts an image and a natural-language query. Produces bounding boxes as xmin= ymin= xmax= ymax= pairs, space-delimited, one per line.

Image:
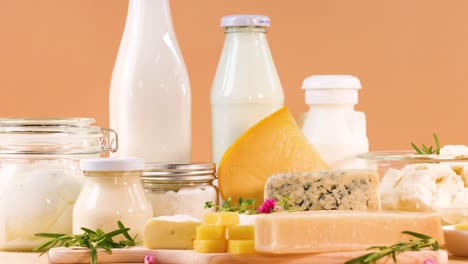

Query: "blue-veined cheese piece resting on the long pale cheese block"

xmin=264 ymin=170 xmax=380 ymax=211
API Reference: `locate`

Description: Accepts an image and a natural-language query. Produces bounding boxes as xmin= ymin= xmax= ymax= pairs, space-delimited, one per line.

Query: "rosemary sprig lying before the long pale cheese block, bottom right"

xmin=345 ymin=231 xmax=439 ymax=264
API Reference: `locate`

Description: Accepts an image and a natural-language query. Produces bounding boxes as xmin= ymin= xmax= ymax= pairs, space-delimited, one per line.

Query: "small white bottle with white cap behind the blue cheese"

xmin=302 ymin=75 xmax=369 ymax=169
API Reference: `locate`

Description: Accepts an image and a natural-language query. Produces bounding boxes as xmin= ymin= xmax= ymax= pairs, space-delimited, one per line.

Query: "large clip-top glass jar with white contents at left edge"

xmin=0 ymin=118 xmax=117 ymax=251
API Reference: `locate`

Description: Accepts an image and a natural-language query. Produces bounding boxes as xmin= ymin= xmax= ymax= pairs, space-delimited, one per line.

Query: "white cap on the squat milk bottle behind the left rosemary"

xmin=80 ymin=158 xmax=145 ymax=171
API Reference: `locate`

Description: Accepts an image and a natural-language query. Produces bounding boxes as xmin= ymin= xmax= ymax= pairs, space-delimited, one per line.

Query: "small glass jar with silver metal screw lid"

xmin=142 ymin=163 xmax=218 ymax=220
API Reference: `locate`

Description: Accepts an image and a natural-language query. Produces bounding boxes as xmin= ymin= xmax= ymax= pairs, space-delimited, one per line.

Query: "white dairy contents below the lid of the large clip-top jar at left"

xmin=0 ymin=160 xmax=83 ymax=250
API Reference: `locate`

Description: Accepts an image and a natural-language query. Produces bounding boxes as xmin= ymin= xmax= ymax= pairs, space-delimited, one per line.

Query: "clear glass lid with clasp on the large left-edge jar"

xmin=0 ymin=118 xmax=118 ymax=155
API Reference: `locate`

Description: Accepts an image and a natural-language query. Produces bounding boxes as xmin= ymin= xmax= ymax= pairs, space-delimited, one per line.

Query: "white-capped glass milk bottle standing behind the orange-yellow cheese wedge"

xmin=211 ymin=15 xmax=284 ymax=165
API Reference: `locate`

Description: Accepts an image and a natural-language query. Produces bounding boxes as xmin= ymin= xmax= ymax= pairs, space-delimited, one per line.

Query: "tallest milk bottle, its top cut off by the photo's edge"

xmin=110 ymin=0 xmax=191 ymax=163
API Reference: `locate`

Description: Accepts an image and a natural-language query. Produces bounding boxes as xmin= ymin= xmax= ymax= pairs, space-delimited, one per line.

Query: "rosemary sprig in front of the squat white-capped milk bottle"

xmin=33 ymin=221 xmax=136 ymax=264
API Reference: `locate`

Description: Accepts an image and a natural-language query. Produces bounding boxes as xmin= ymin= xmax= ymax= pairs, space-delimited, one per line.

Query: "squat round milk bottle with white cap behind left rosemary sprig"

xmin=73 ymin=158 xmax=153 ymax=241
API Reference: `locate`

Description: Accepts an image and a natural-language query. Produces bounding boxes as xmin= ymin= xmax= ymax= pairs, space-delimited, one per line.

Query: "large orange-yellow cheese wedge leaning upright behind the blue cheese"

xmin=218 ymin=107 xmax=329 ymax=204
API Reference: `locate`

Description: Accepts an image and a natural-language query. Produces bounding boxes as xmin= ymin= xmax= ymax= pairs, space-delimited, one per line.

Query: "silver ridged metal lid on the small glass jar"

xmin=142 ymin=163 xmax=216 ymax=183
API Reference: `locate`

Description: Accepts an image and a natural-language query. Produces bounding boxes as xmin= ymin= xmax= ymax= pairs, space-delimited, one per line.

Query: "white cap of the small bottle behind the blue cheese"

xmin=302 ymin=75 xmax=362 ymax=104
